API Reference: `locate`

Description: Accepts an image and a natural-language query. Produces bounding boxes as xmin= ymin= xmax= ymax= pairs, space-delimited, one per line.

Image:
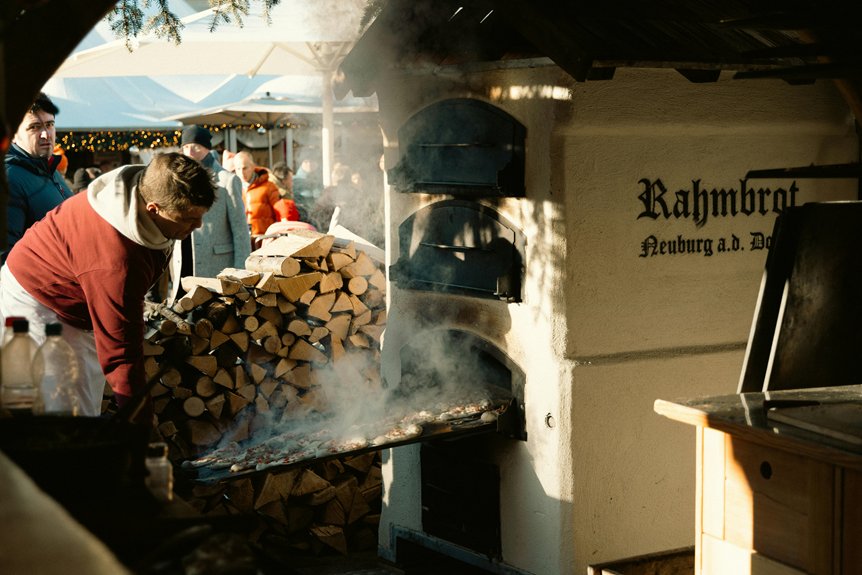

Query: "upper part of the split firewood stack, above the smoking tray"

xmin=145 ymin=231 xmax=386 ymax=460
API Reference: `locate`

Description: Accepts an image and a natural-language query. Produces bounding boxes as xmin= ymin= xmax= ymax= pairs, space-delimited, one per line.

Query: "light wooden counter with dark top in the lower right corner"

xmin=654 ymin=386 xmax=862 ymax=575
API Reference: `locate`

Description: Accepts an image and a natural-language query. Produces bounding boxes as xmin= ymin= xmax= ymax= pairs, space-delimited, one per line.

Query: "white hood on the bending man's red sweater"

xmin=87 ymin=165 xmax=173 ymax=250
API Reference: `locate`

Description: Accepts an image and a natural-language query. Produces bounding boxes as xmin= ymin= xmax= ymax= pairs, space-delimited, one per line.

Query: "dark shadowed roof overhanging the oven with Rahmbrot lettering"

xmin=337 ymin=0 xmax=862 ymax=117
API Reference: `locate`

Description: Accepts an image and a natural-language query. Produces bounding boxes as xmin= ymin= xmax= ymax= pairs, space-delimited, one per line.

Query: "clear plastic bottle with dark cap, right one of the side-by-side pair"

xmin=32 ymin=323 xmax=81 ymax=415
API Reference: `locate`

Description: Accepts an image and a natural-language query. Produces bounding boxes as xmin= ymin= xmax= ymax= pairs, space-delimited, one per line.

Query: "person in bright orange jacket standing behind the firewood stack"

xmin=234 ymin=151 xmax=299 ymax=243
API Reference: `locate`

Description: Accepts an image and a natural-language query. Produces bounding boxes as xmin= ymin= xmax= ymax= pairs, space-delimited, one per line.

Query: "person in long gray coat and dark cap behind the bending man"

xmin=168 ymin=126 xmax=251 ymax=302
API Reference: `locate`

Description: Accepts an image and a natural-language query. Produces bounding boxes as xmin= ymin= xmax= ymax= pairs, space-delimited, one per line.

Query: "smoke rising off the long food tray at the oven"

xmin=213 ymin=329 xmax=512 ymax=454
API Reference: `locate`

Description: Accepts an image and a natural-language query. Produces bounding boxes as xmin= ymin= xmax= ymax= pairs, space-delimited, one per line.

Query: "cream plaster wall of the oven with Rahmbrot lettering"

xmin=379 ymin=64 xmax=858 ymax=575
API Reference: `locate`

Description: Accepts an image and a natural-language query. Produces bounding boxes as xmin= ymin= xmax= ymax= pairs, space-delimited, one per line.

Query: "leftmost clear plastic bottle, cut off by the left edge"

xmin=0 ymin=318 xmax=42 ymax=415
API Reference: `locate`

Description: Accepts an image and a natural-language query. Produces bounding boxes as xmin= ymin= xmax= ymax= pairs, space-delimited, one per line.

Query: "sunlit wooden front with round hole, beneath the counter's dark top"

xmin=695 ymin=428 xmax=840 ymax=575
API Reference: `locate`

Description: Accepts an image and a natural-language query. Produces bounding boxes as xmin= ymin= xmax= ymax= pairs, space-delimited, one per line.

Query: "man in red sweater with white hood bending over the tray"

xmin=0 ymin=153 xmax=215 ymax=416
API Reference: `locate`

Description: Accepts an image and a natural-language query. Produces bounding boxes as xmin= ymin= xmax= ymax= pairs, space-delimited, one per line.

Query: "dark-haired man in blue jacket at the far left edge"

xmin=2 ymin=93 xmax=72 ymax=262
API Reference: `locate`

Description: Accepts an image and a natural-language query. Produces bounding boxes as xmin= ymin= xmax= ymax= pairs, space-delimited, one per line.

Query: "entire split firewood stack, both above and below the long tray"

xmin=145 ymin=230 xmax=386 ymax=553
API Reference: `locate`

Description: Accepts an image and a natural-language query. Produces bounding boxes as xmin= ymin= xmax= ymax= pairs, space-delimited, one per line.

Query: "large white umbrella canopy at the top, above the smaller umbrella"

xmin=54 ymin=0 xmax=365 ymax=78
